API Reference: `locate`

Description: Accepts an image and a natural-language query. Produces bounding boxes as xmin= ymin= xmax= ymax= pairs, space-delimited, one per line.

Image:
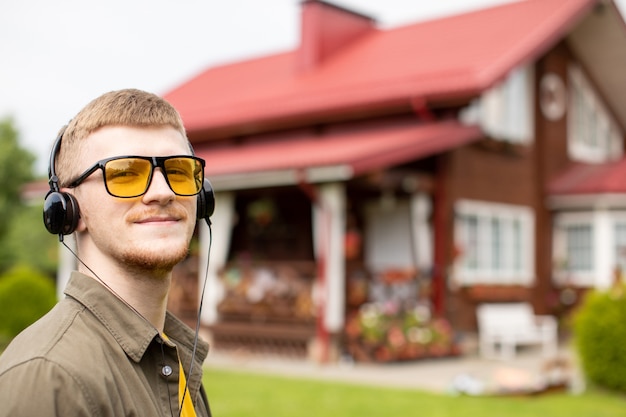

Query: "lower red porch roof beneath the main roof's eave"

xmin=197 ymin=121 xmax=482 ymax=180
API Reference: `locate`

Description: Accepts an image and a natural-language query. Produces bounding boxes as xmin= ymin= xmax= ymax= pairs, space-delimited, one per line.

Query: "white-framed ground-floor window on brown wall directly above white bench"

xmin=455 ymin=200 xmax=534 ymax=285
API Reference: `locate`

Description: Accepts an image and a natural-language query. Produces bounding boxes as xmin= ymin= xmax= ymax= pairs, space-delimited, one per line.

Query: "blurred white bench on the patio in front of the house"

xmin=476 ymin=302 xmax=557 ymax=359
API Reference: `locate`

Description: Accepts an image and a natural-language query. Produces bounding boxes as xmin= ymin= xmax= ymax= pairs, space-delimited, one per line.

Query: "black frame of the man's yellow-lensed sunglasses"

xmin=68 ymin=155 xmax=206 ymax=198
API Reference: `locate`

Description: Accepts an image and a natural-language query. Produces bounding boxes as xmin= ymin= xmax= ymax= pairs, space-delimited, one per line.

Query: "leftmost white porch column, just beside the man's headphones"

xmin=198 ymin=192 xmax=235 ymax=326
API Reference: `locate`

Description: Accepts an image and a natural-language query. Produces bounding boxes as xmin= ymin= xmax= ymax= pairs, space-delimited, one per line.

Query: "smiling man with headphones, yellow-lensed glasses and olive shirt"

xmin=0 ymin=90 xmax=212 ymax=417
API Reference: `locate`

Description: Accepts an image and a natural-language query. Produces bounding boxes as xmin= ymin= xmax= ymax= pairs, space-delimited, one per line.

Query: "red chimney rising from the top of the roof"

xmin=297 ymin=0 xmax=376 ymax=71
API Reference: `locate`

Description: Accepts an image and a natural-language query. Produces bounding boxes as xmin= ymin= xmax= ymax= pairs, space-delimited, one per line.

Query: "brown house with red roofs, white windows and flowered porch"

xmin=165 ymin=0 xmax=626 ymax=360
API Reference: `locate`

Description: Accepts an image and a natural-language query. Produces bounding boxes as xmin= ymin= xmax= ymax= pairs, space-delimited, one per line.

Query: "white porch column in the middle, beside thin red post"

xmin=314 ymin=183 xmax=346 ymax=333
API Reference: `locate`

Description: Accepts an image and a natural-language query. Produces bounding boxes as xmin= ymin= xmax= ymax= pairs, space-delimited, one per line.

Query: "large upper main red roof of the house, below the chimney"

xmin=165 ymin=0 xmax=596 ymax=133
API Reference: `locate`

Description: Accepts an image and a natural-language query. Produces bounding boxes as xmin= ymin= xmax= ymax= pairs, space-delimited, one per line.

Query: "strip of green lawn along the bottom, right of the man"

xmin=204 ymin=368 xmax=626 ymax=417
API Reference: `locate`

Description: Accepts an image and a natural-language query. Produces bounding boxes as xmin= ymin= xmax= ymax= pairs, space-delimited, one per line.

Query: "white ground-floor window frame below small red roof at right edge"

xmin=552 ymin=210 xmax=626 ymax=288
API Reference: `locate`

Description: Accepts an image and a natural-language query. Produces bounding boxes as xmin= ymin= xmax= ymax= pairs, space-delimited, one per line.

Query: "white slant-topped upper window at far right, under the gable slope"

xmin=567 ymin=64 xmax=624 ymax=163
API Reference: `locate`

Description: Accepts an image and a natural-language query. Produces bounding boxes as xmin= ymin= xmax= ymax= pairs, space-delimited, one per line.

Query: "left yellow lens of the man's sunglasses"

xmin=104 ymin=158 xmax=152 ymax=197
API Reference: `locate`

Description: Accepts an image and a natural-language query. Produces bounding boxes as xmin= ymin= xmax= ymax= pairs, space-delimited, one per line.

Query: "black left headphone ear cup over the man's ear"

xmin=43 ymin=191 xmax=80 ymax=236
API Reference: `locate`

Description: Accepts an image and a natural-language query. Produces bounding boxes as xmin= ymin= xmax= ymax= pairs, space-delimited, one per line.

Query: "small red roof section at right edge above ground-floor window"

xmin=548 ymin=159 xmax=626 ymax=195
